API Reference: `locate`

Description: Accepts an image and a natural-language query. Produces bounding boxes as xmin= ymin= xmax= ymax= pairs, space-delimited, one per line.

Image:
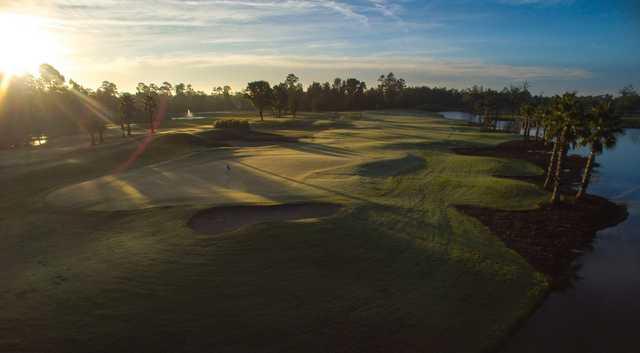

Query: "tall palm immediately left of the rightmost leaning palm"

xmin=551 ymin=93 xmax=582 ymax=204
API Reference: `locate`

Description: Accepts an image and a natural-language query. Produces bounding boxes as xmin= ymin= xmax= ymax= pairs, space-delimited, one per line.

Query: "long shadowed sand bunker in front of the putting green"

xmin=189 ymin=203 xmax=341 ymax=235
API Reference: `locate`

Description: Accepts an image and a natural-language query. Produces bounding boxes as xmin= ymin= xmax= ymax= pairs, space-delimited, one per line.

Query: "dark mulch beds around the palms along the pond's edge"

xmin=455 ymin=141 xmax=628 ymax=288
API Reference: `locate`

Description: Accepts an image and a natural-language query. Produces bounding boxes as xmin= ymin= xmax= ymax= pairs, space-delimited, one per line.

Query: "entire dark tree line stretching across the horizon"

xmin=0 ymin=64 xmax=640 ymax=148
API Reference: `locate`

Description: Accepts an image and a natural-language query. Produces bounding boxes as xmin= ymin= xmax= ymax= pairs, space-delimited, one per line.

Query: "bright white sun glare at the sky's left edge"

xmin=0 ymin=14 xmax=60 ymax=75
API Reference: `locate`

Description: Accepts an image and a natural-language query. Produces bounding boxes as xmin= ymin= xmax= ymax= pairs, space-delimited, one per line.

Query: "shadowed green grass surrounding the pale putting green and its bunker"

xmin=0 ymin=112 xmax=546 ymax=352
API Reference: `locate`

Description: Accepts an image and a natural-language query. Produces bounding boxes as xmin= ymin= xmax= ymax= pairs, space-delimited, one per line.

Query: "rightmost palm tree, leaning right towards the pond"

xmin=576 ymin=100 xmax=622 ymax=199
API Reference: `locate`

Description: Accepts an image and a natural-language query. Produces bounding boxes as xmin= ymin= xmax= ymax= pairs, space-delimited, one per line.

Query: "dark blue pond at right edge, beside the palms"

xmin=504 ymin=129 xmax=640 ymax=353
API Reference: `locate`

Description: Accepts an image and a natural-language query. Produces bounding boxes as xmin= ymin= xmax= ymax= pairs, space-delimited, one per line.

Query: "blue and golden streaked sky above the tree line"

xmin=0 ymin=0 xmax=640 ymax=94
